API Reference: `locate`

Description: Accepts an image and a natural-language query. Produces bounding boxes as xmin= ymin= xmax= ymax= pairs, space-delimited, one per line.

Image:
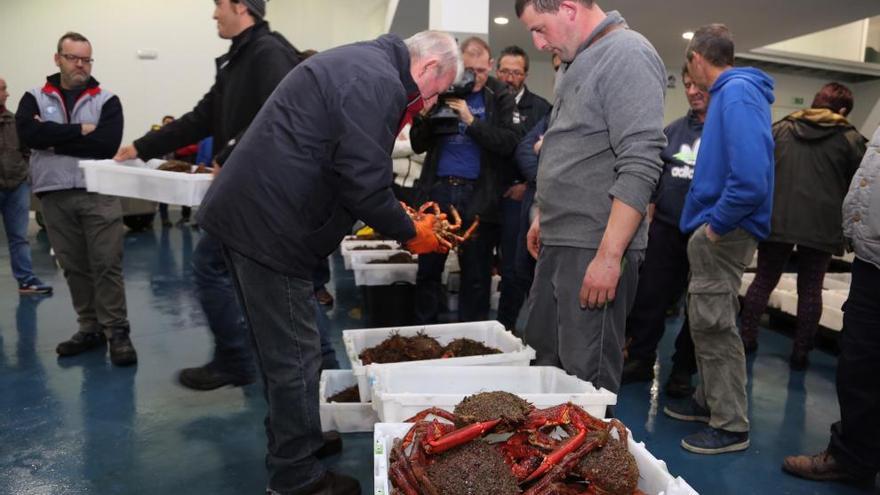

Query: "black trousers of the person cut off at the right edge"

xmin=828 ymin=258 xmax=880 ymax=480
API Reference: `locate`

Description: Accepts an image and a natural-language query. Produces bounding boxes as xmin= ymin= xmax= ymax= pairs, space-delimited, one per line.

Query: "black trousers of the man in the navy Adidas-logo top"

xmin=626 ymin=220 xmax=697 ymax=374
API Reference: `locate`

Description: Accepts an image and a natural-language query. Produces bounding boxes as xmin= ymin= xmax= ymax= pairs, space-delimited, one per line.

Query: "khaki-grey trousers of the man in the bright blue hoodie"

xmin=688 ymin=225 xmax=758 ymax=432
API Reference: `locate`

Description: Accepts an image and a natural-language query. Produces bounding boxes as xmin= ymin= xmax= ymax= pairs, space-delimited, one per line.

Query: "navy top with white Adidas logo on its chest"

xmin=651 ymin=111 xmax=703 ymax=228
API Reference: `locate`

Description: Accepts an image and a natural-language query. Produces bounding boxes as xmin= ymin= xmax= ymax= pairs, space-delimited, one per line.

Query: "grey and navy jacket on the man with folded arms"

xmin=15 ymin=74 xmax=123 ymax=195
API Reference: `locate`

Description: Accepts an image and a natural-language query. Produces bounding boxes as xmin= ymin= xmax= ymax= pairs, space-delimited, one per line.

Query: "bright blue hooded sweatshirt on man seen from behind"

xmin=679 ymin=68 xmax=775 ymax=240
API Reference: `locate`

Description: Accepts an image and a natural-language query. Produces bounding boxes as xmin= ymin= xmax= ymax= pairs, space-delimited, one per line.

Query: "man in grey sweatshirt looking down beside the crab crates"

xmin=516 ymin=0 xmax=666 ymax=393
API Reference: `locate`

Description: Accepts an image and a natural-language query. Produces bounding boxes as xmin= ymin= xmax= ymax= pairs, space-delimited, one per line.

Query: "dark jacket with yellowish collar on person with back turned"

xmin=766 ymin=108 xmax=867 ymax=255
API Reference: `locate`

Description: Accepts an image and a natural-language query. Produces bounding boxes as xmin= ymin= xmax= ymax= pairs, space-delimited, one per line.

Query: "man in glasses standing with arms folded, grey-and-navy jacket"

xmin=15 ymin=32 xmax=137 ymax=366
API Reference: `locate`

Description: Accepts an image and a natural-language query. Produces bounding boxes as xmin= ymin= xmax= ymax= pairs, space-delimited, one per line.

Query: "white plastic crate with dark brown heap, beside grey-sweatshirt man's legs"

xmin=342 ymin=321 xmax=535 ymax=401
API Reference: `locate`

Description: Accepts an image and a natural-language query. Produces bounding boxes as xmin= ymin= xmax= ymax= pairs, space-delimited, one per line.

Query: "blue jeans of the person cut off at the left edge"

xmin=0 ymin=182 xmax=34 ymax=282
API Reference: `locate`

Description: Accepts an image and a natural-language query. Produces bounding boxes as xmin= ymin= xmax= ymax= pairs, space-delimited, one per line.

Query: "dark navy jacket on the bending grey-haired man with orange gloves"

xmin=199 ymin=35 xmax=418 ymax=280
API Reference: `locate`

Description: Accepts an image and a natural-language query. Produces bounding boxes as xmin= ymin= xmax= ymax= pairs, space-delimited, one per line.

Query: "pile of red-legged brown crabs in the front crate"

xmin=389 ymin=392 xmax=642 ymax=495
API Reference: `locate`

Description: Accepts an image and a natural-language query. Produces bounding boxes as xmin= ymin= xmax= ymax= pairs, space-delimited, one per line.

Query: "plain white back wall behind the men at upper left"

xmin=0 ymin=0 xmax=387 ymax=146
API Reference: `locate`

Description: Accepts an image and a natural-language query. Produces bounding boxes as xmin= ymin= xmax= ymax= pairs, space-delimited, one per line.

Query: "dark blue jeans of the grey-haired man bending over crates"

xmin=225 ymin=249 xmax=324 ymax=494
